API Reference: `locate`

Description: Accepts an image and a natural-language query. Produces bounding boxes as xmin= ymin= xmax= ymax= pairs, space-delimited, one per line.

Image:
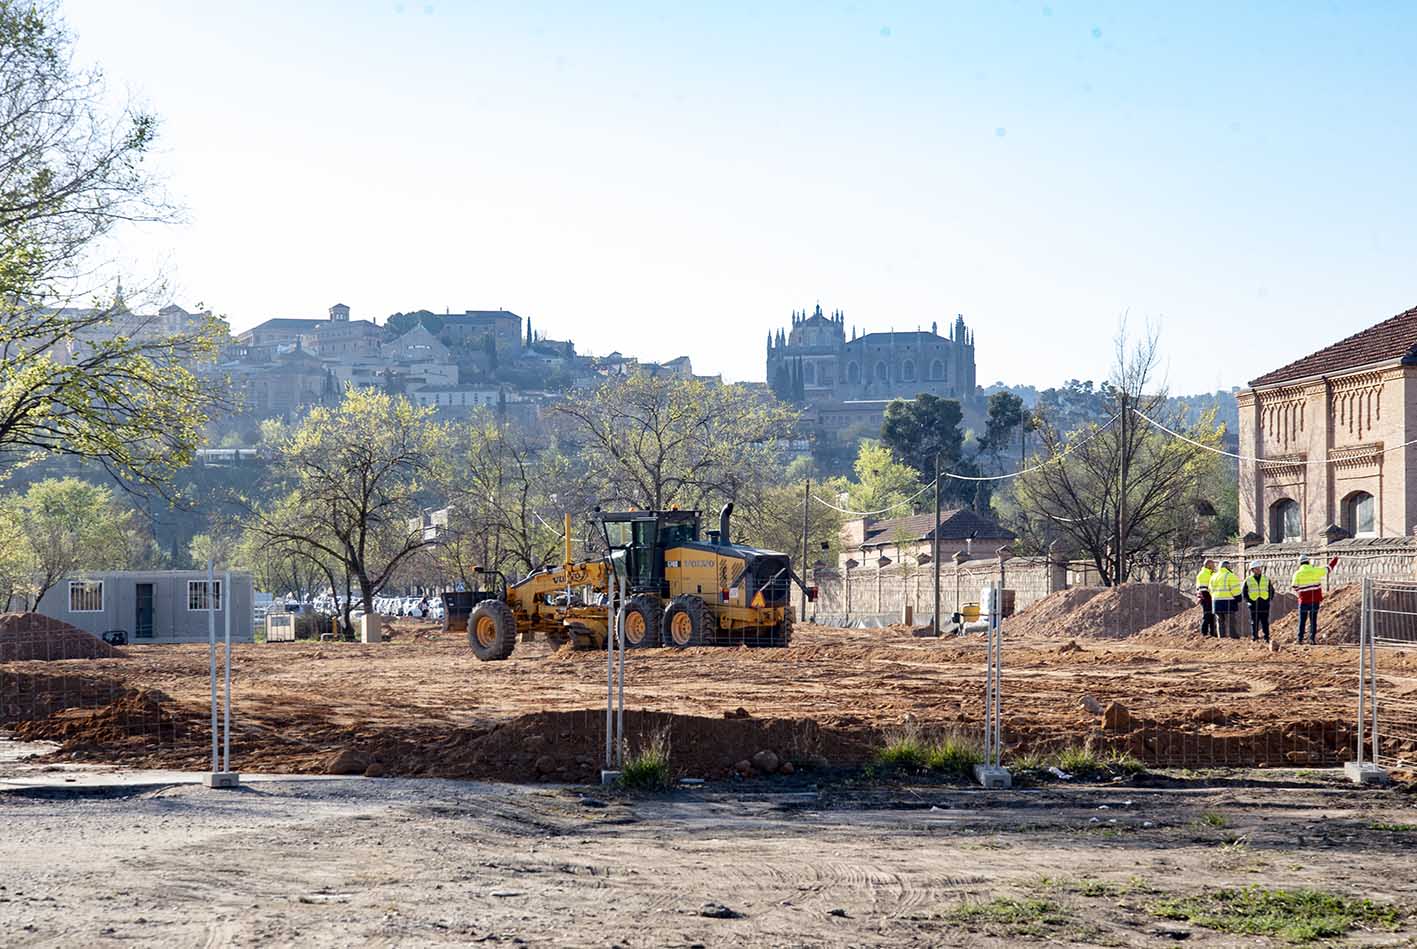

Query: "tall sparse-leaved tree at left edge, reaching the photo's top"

xmin=0 ymin=3 xmax=221 ymax=484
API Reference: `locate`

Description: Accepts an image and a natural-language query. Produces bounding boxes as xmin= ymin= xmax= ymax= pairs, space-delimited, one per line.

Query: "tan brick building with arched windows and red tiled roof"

xmin=1238 ymin=307 xmax=1417 ymax=544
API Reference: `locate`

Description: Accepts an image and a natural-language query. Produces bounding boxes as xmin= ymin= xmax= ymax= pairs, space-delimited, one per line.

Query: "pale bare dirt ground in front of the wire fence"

xmin=0 ymin=772 xmax=1417 ymax=948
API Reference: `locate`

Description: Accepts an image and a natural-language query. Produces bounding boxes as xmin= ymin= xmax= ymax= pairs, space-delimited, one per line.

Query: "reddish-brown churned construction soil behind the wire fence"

xmin=0 ymin=585 xmax=1417 ymax=780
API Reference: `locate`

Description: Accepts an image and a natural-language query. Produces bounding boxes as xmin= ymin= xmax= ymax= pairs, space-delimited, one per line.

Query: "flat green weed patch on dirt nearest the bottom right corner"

xmin=1148 ymin=887 xmax=1401 ymax=943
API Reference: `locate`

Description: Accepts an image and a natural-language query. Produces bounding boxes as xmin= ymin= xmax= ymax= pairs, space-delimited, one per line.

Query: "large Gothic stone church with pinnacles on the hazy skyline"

xmin=768 ymin=303 xmax=975 ymax=405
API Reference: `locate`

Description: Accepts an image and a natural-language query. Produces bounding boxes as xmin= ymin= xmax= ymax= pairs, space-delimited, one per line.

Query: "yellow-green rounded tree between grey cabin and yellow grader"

xmin=251 ymin=388 xmax=442 ymax=626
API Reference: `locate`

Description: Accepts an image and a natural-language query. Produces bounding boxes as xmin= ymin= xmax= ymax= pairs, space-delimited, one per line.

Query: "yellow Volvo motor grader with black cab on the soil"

xmin=468 ymin=504 xmax=816 ymax=660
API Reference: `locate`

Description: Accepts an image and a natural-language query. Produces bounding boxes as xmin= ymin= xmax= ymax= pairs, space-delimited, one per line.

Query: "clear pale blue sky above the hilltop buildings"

xmin=64 ymin=0 xmax=1417 ymax=391
